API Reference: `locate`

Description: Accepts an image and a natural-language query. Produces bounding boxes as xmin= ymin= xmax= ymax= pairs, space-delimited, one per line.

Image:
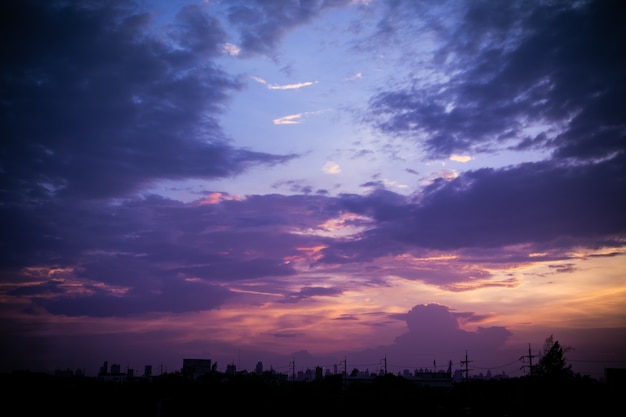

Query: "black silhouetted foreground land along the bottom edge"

xmin=1 ymin=371 xmax=626 ymax=417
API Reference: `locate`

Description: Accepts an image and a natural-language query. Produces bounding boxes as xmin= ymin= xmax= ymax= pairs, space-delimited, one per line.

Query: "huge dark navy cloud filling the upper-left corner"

xmin=0 ymin=1 xmax=291 ymax=202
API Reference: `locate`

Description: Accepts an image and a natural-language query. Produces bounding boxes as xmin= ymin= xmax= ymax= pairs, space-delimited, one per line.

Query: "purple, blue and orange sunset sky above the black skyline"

xmin=0 ymin=0 xmax=626 ymax=378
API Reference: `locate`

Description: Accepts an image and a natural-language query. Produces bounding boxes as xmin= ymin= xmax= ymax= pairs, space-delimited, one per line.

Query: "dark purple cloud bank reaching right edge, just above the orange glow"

xmin=322 ymin=156 xmax=626 ymax=263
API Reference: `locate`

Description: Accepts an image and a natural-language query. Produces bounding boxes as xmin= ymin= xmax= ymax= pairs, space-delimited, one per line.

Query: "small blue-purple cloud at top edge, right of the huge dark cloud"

xmin=222 ymin=0 xmax=350 ymax=55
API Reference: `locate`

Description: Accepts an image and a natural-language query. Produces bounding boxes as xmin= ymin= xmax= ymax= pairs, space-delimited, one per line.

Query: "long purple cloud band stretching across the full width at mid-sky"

xmin=0 ymin=144 xmax=626 ymax=315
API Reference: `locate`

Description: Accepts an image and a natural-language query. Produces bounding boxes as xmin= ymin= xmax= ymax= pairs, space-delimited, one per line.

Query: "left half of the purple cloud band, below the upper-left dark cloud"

xmin=2 ymin=195 xmax=340 ymax=316
